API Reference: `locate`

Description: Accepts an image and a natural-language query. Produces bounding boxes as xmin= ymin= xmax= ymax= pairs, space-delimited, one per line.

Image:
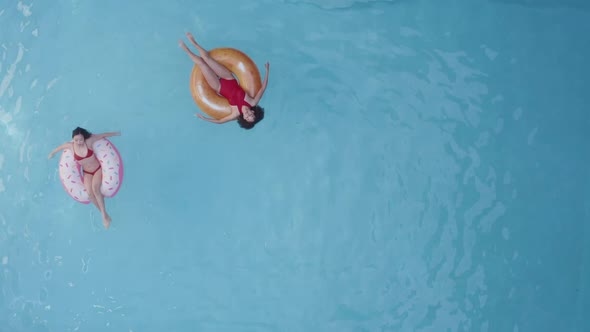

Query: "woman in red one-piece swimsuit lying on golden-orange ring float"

xmin=179 ymin=32 xmax=269 ymax=129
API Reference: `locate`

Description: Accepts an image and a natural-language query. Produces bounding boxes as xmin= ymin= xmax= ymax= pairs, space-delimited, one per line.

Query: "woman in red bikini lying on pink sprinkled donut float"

xmin=49 ymin=127 xmax=121 ymax=229
